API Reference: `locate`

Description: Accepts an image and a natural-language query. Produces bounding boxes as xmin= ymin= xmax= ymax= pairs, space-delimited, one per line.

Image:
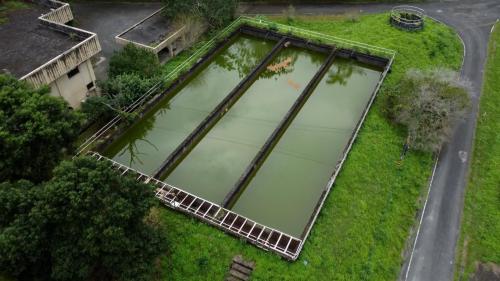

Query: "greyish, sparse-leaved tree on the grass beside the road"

xmin=388 ymin=69 xmax=470 ymax=152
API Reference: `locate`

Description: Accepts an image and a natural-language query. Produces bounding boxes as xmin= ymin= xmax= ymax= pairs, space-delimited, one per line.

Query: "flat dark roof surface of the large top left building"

xmin=0 ymin=5 xmax=83 ymax=78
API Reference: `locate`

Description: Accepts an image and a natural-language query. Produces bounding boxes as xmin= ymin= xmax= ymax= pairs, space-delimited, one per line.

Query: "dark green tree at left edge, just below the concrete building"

xmin=0 ymin=75 xmax=82 ymax=182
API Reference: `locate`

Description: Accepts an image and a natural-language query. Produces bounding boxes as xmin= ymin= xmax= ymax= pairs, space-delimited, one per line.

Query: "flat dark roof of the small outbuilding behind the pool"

xmin=120 ymin=9 xmax=177 ymax=47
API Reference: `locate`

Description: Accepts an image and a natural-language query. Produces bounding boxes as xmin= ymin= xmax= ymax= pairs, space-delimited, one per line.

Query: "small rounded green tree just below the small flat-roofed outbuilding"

xmin=108 ymin=44 xmax=160 ymax=78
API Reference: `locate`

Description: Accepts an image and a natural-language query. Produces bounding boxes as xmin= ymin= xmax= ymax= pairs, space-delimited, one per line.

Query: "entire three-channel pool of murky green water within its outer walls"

xmin=104 ymin=29 xmax=388 ymax=247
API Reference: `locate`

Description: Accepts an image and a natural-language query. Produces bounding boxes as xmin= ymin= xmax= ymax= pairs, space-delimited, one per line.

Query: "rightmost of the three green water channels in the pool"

xmin=232 ymin=58 xmax=381 ymax=237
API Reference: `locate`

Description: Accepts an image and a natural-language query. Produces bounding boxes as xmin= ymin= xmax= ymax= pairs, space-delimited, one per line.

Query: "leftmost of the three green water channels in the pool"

xmin=104 ymin=35 xmax=276 ymax=174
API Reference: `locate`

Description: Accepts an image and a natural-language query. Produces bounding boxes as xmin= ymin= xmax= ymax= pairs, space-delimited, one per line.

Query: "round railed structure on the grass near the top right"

xmin=390 ymin=5 xmax=425 ymax=31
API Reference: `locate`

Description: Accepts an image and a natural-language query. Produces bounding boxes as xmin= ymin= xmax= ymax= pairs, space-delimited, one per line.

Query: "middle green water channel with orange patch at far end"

xmin=162 ymin=47 xmax=326 ymax=202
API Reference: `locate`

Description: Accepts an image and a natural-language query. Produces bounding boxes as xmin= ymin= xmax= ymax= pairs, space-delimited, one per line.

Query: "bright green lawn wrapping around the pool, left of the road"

xmin=158 ymin=14 xmax=463 ymax=280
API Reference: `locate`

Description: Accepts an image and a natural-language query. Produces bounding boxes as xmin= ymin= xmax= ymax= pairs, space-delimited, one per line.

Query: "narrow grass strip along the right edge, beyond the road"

xmin=457 ymin=24 xmax=500 ymax=280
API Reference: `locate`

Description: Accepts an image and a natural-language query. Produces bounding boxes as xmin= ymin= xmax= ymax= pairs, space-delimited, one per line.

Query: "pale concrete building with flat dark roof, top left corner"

xmin=0 ymin=0 xmax=101 ymax=108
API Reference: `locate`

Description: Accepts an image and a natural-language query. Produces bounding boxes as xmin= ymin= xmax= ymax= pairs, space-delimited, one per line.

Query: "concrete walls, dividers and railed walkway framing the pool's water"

xmin=78 ymin=18 xmax=395 ymax=260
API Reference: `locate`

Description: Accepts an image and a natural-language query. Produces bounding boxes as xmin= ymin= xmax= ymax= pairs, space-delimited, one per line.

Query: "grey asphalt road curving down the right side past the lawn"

xmin=241 ymin=0 xmax=500 ymax=281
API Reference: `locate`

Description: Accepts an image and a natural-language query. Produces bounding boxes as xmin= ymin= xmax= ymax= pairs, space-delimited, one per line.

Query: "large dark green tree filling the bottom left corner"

xmin=0 ymin=157 xmax=166 ymax=280
